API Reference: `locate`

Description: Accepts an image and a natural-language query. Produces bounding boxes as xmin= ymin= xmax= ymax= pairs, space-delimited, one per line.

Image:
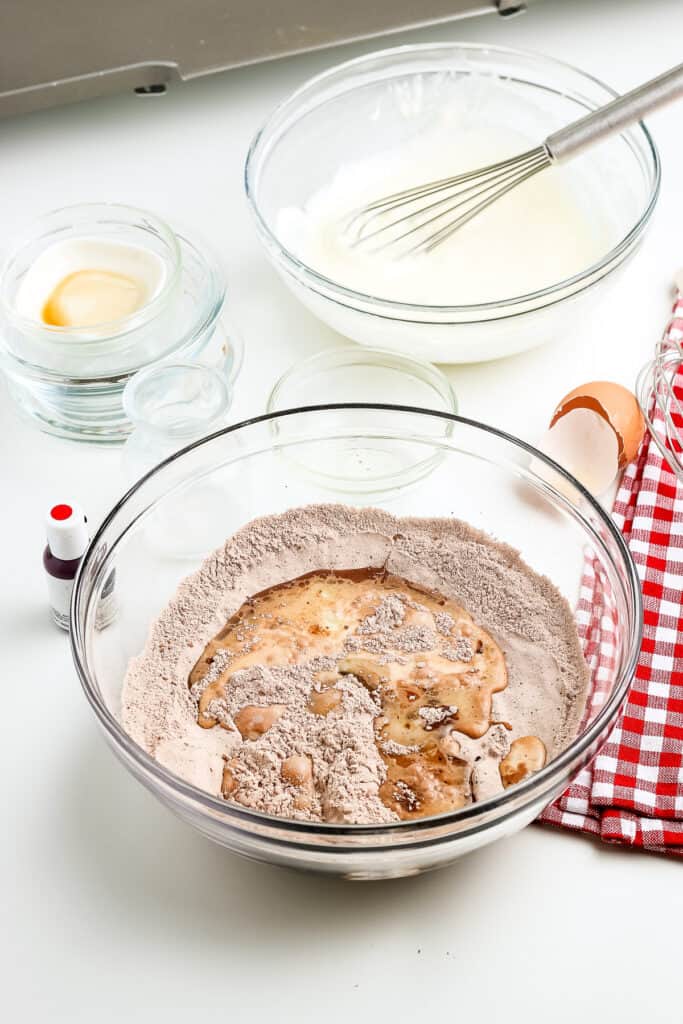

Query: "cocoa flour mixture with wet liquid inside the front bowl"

xmin=123 ymin=505 xmax=588 ymax=823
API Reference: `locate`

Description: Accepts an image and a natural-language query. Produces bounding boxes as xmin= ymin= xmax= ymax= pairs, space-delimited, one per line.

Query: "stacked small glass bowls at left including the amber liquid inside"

xmin=0 ymin=204 xmax=242 ymax=443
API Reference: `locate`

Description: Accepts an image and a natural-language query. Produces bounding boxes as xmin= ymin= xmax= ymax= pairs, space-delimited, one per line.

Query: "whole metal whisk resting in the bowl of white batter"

xmin=342 ymin=65 xmax=683 ymax=256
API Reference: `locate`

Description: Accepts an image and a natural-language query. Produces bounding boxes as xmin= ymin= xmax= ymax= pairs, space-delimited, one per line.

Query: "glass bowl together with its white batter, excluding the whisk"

xmin=245 ymin=43 xmax=659 ymax=362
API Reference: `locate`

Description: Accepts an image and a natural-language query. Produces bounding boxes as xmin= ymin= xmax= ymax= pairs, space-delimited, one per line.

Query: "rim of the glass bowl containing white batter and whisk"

xmin=244 ymin=42 xmax=661 ymax=323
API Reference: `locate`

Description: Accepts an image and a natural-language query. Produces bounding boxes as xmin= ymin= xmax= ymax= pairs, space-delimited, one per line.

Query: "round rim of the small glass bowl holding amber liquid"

xmin=0 ymin=202 xmax=182 ymax=350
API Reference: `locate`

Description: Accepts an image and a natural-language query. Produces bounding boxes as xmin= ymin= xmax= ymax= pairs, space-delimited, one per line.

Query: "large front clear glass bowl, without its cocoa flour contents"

xmin=71 ymin=404 xmax=642 ymax=879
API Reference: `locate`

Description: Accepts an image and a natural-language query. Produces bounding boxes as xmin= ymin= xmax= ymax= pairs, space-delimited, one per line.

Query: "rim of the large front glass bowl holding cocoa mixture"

xmin=70 ymin=402 xmax=643 ymax=852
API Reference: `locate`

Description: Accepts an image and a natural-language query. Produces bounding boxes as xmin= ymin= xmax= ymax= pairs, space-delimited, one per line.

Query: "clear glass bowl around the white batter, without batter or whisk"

xmin=245 ymin=43 xmax=659 ymax=362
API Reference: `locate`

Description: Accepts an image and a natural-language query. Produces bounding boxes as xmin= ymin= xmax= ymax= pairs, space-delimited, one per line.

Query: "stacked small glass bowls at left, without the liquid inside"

xmin=0 ymin=204 xmax=242 ymax=443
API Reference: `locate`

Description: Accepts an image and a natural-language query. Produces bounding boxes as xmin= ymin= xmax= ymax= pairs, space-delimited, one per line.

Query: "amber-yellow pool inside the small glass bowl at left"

xmin=42 ymin=270 xmax=145 ymax=328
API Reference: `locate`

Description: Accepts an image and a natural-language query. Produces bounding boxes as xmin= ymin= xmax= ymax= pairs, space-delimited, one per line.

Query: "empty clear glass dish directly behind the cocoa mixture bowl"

xmin=266 ymin=345 xmax=458 ymax=502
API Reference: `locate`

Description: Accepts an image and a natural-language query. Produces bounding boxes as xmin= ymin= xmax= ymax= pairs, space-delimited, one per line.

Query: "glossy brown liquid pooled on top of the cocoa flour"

xmin=189 ymin=568 xmax=545 ymax=819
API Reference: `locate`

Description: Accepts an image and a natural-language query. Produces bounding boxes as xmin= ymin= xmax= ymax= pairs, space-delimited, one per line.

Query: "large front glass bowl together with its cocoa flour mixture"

xmin=71 ymin=403 xmax=641 ymax=879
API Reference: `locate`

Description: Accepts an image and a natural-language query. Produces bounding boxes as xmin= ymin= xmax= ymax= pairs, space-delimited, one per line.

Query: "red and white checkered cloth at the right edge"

xmin=540 ymin=295 xmax=683 ymax=857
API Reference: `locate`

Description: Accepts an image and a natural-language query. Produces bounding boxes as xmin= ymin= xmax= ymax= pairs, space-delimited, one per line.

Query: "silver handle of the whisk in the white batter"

xmin=545 ymin=65 xmax=683 ymax=163
